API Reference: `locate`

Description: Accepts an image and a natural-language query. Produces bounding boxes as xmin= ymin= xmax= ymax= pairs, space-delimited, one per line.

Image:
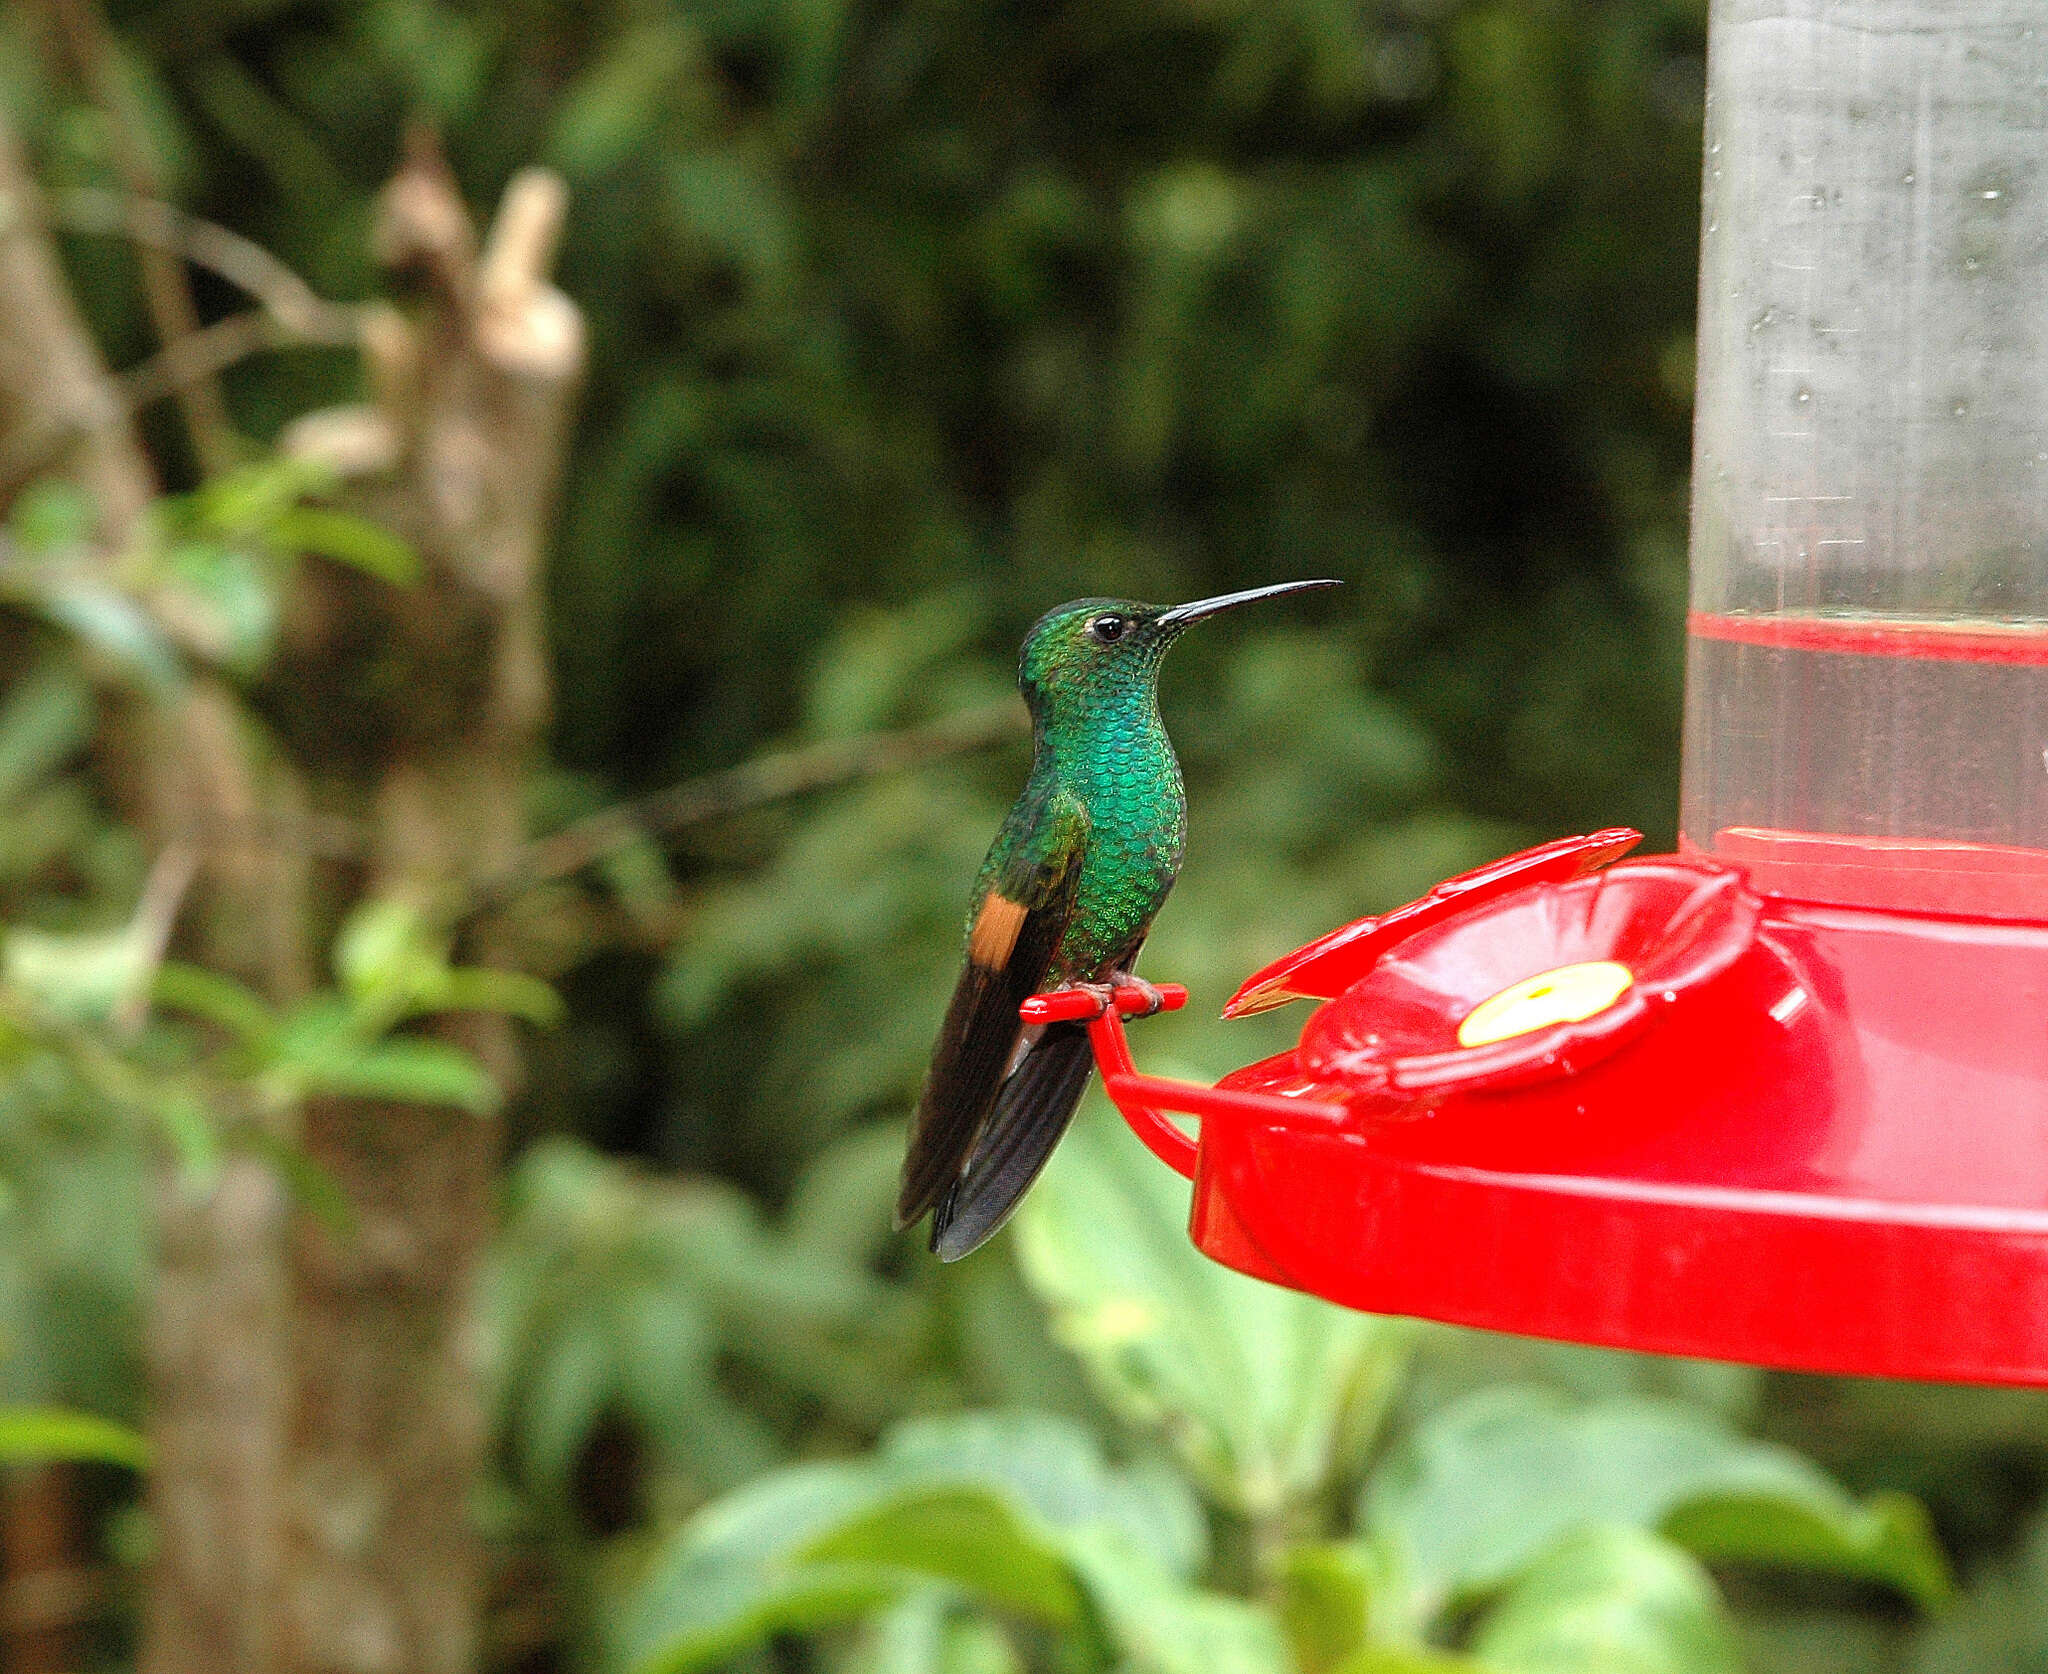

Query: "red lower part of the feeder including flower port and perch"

xmin=1032 ymin=832 xmax=2048 ymax=1383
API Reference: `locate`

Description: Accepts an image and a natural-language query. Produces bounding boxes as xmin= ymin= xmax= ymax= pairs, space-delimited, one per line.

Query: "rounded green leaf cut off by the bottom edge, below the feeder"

xmin=1473 ymin=1526 xmax=1741 ymax=1674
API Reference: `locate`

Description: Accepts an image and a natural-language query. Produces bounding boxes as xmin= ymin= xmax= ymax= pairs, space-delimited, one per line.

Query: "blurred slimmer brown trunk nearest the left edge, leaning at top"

xmin=0 ymin=101 xmax=305 ymax=1674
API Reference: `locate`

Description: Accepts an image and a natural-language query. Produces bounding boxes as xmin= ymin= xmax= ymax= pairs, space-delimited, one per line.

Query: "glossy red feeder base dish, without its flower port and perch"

xmin=1192 ymin=899 xmax=2048 ymax=1383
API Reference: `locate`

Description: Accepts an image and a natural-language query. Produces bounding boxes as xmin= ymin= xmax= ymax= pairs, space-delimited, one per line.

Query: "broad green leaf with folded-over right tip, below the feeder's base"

xmin=1360 ymin=1387 xmax=1948 ymax=1615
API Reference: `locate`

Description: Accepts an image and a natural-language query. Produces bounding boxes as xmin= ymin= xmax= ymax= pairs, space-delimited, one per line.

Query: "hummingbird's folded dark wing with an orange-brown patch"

xmin=895 ymin=791 xmax=1087 ymax=1227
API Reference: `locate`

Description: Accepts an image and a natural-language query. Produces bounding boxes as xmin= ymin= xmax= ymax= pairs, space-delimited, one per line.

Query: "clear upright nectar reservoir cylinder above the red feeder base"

xmin=1683 ymin=0 xmax=2048 ymax=916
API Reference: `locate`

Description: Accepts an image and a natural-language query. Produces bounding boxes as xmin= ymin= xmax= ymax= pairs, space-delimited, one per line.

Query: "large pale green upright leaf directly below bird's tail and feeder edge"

xmin=1018 ymin=1111 xmax=1411 ymax=1516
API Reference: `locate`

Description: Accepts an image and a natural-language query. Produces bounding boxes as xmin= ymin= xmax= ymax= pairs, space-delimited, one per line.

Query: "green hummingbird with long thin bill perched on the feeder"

xmin=895 ymin=582 xmax=1337 ymax=1262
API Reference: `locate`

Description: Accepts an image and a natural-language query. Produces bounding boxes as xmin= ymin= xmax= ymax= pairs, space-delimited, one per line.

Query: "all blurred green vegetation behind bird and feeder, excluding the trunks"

xmin=0 ymin=0 xmax=2048 ymax=1674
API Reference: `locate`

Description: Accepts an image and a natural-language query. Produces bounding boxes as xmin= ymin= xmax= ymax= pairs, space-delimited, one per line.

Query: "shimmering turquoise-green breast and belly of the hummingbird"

xmin=1053 ymin=705 xmax=1188 ymax=981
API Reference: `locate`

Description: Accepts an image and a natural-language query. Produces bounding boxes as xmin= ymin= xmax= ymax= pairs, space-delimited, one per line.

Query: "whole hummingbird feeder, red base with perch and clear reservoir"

xmin=1026 ymin=0 xmax=2048 ymax=1383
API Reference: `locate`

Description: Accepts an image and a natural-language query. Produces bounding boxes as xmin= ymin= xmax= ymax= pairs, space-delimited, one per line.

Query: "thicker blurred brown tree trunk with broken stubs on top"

xmin=287 ymin=150 xmax=582 ymax=1674
